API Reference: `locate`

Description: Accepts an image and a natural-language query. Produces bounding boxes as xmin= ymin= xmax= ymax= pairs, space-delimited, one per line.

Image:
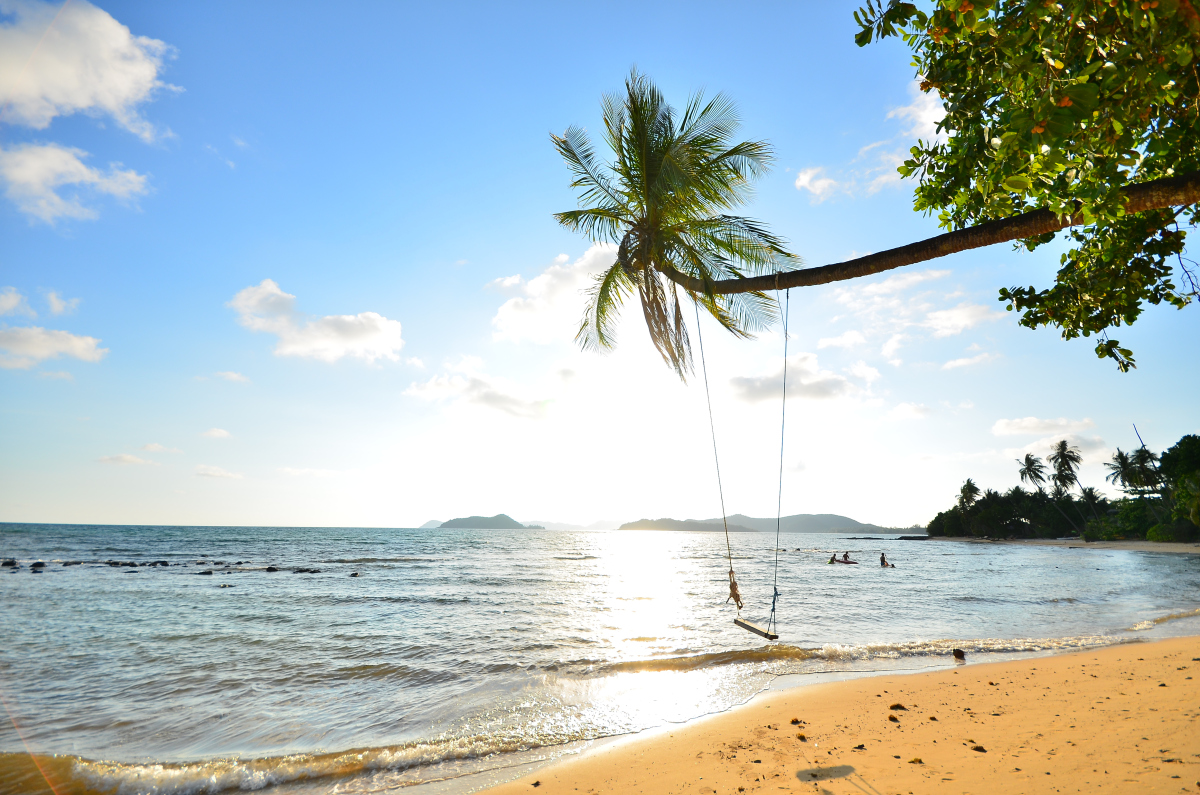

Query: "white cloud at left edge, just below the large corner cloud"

xmin=0 ymin=144 xmax=146 ymax=223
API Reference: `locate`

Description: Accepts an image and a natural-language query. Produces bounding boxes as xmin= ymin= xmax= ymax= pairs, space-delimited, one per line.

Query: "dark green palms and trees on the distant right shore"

xmin=928 ymin=435 xmax=1200 ymax=542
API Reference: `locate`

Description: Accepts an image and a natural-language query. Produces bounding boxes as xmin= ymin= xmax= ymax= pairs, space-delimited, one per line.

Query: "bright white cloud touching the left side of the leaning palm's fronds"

xmin=492 ymin=243 xmax=617 ymax=345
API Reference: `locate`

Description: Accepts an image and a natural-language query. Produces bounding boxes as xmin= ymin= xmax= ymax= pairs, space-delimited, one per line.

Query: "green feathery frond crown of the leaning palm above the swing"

xmin=551 ymin=70 xmax=800 ymax=378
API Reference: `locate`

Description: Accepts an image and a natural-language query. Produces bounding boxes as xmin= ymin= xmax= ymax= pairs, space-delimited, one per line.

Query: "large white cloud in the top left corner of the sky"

xmin=0 ymin=0 xmax=175 ymax=142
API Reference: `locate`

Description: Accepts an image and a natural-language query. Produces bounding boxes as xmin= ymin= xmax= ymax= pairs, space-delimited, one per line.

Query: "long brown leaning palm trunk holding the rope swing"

xmin=662 ymin=172 xmax=1200 ymax=295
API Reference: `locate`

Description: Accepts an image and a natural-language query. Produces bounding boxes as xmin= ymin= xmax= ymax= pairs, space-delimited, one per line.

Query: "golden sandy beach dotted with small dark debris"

xmin=486 ymin=636 xmax=1200 ymax=795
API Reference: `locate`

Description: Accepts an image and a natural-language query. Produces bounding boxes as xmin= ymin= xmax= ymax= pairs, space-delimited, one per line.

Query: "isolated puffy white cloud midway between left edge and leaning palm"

xmin=229 ymin=279 xmax=404 ymax=364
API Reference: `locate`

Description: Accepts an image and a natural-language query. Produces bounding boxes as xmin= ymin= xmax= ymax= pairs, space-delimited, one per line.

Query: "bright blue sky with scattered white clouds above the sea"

xmin=0 ymin=0 xmax=1200 ymax=527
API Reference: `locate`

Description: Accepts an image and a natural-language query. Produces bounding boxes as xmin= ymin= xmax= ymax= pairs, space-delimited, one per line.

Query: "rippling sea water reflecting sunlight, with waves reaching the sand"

xmin=0 ymin=525 xmax=1200 ymax=795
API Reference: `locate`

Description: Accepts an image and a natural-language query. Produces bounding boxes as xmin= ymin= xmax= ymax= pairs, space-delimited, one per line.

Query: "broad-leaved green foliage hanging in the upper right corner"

xmin=856 ymin=0 xmax=1200 ymax=371
